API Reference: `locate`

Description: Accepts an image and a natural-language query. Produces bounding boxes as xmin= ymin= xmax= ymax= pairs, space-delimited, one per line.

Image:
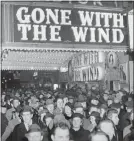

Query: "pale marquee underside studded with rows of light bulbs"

xmin=1 ymin=49 xmax=126 ymax=71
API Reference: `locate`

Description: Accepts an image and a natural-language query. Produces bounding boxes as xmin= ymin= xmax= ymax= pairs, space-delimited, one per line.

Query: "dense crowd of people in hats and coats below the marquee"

xmin=1 ymin=87 xmax=134 ymax=141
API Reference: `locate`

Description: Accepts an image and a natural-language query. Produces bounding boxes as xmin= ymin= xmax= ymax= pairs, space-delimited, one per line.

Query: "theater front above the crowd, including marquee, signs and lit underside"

xmin=2 ymin=0 xmax=132 ymax=90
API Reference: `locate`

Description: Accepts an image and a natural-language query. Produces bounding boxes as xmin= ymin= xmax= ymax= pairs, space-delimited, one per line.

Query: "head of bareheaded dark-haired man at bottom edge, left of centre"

xmin=51 ymin=122 xmax=70 ymax=141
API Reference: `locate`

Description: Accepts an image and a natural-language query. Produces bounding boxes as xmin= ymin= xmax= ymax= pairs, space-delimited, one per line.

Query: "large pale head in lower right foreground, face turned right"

xmin=98 ymin=120 xmax=115 ymax=140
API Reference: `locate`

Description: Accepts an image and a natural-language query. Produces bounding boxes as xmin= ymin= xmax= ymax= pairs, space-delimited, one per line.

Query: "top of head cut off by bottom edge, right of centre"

xmin=89 ymin=131 xmax=110 ymax=141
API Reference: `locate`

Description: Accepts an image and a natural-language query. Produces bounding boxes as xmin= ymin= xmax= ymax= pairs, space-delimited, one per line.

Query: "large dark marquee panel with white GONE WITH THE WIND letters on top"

xmin=14 ymin=6 xmax=127 ymax=45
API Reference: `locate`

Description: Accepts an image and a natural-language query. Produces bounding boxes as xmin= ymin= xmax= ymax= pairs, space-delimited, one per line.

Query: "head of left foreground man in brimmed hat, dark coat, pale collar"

xmin=20 ymin=105 xmax=33 ymax=124
